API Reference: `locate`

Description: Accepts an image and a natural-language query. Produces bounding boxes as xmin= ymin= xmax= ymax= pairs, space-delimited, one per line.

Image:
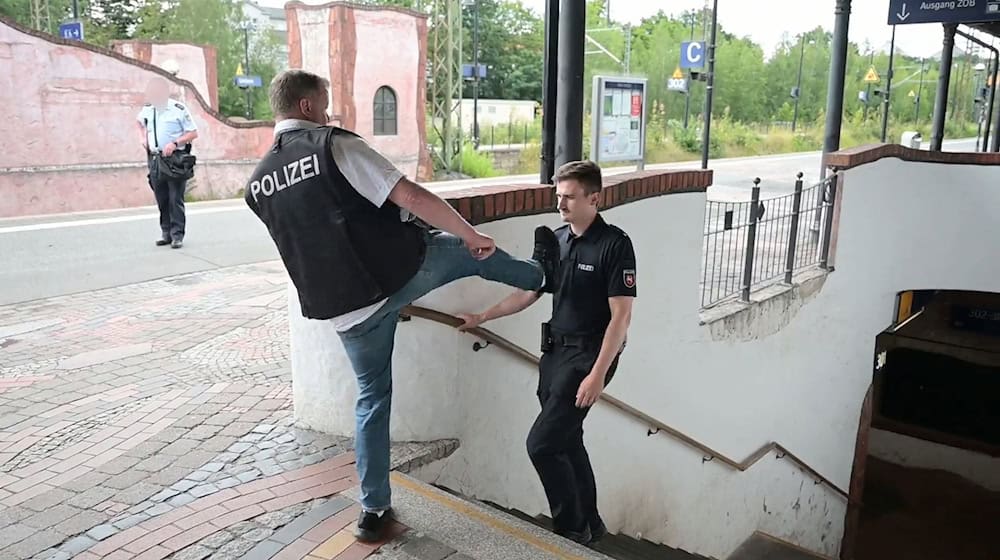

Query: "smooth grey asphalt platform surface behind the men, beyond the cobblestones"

xmin=0 ymin=140 xmax=973 ymax=304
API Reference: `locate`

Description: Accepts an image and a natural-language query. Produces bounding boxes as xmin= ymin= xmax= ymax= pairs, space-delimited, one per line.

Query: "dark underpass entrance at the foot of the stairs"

xmin=843 ymin=290 xmax=1000 ymax=560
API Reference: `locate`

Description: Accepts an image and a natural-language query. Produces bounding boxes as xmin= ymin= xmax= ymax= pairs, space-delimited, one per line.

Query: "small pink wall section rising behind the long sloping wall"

xmin=111 ymin=41 xmax=219 ymax=110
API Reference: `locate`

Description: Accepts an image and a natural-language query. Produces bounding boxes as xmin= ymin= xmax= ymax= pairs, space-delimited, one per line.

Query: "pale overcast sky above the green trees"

xmin=259 ymin=0 xmax=989 ymax=56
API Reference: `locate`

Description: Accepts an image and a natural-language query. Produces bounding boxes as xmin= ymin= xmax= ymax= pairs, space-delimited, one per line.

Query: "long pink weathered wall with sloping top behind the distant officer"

xmin=0 ymin=19 xmax=273 ymax=217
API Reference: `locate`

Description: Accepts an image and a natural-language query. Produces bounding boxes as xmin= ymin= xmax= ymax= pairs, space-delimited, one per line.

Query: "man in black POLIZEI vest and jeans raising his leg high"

xmin=245 ymin=70 xmax=559 ymax=542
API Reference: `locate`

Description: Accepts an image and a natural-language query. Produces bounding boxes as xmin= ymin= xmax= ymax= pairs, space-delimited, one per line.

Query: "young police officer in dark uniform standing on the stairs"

xmin=461 ymin=161 xmax=636 ymax=544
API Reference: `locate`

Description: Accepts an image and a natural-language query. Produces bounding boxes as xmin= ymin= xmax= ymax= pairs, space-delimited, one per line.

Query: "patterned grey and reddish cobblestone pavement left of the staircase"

xmin=0 ymin=263 xmax=457 ymax=560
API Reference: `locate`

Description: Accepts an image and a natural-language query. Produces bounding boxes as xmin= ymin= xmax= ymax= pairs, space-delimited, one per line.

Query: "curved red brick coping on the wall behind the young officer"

xmin=444 ymin=170 xmax=712 ymax=225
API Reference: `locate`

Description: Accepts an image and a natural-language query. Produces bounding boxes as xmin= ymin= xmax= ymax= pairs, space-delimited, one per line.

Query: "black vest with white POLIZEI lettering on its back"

xmin=244 ymin=127 xmax=426 ymax=319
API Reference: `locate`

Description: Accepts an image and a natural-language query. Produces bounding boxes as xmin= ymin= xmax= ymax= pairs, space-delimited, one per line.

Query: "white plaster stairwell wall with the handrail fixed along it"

xmin=292 ymin=160 xmax=1000 ymax=558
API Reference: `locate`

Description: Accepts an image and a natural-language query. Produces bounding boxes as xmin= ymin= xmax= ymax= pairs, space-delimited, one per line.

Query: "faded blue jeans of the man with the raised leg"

xmin=340 ymin=232 xmax=544 ymax=511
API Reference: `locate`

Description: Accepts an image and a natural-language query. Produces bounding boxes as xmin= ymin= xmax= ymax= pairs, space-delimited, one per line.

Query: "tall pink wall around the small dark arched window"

xmin=285 ymin=2 xmax=433 ymax=180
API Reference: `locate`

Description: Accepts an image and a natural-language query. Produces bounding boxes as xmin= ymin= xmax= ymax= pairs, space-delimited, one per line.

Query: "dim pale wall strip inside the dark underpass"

xmin=868 ymin=429 xmax=1000 ymax=491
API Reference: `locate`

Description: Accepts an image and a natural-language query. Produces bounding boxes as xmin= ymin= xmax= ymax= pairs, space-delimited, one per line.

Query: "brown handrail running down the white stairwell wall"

xmin=402 ymin=305 xmax=848 ymax=499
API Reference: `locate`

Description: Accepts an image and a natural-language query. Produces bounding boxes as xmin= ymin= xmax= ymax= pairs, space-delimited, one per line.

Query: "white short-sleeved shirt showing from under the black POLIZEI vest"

xmin=274 ymin=119 xmax=410 ymax=332
